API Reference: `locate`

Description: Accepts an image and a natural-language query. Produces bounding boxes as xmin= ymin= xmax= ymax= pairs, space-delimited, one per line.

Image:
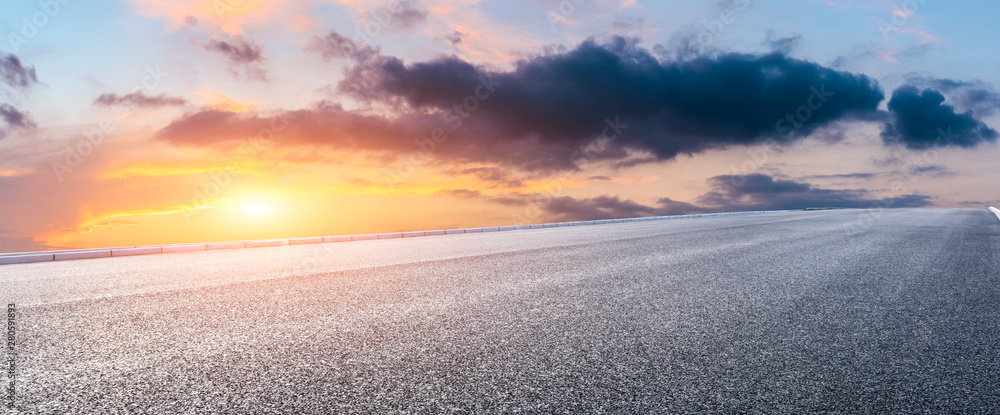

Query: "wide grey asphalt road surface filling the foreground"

xmin=0 ymin=209 xmax=1000 ymax=414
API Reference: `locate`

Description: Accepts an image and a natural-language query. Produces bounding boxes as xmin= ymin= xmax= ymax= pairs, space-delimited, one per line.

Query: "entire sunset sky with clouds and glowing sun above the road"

xmin=0 ymin=0 xmax=1000 ymax=252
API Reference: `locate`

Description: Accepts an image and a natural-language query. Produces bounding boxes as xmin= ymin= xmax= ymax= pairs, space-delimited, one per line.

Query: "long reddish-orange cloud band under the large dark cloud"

xmin=156 ymin=102 xmax=616 ymax=172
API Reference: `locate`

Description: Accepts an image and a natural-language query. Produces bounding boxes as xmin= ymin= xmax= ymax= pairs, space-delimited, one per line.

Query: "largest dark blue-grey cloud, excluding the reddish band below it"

xmin=339 ymin=38 xmax=883 ymax=159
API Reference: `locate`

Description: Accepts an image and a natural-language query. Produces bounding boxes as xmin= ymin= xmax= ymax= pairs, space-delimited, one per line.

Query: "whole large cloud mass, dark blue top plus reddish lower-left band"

xmin=170 ymin=32 xmax=883 ymax=173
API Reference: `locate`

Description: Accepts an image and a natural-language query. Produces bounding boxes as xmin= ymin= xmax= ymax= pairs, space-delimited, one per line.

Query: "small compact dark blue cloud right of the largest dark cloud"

xmin=881 ymin=85 xmax=997 ymax=150
